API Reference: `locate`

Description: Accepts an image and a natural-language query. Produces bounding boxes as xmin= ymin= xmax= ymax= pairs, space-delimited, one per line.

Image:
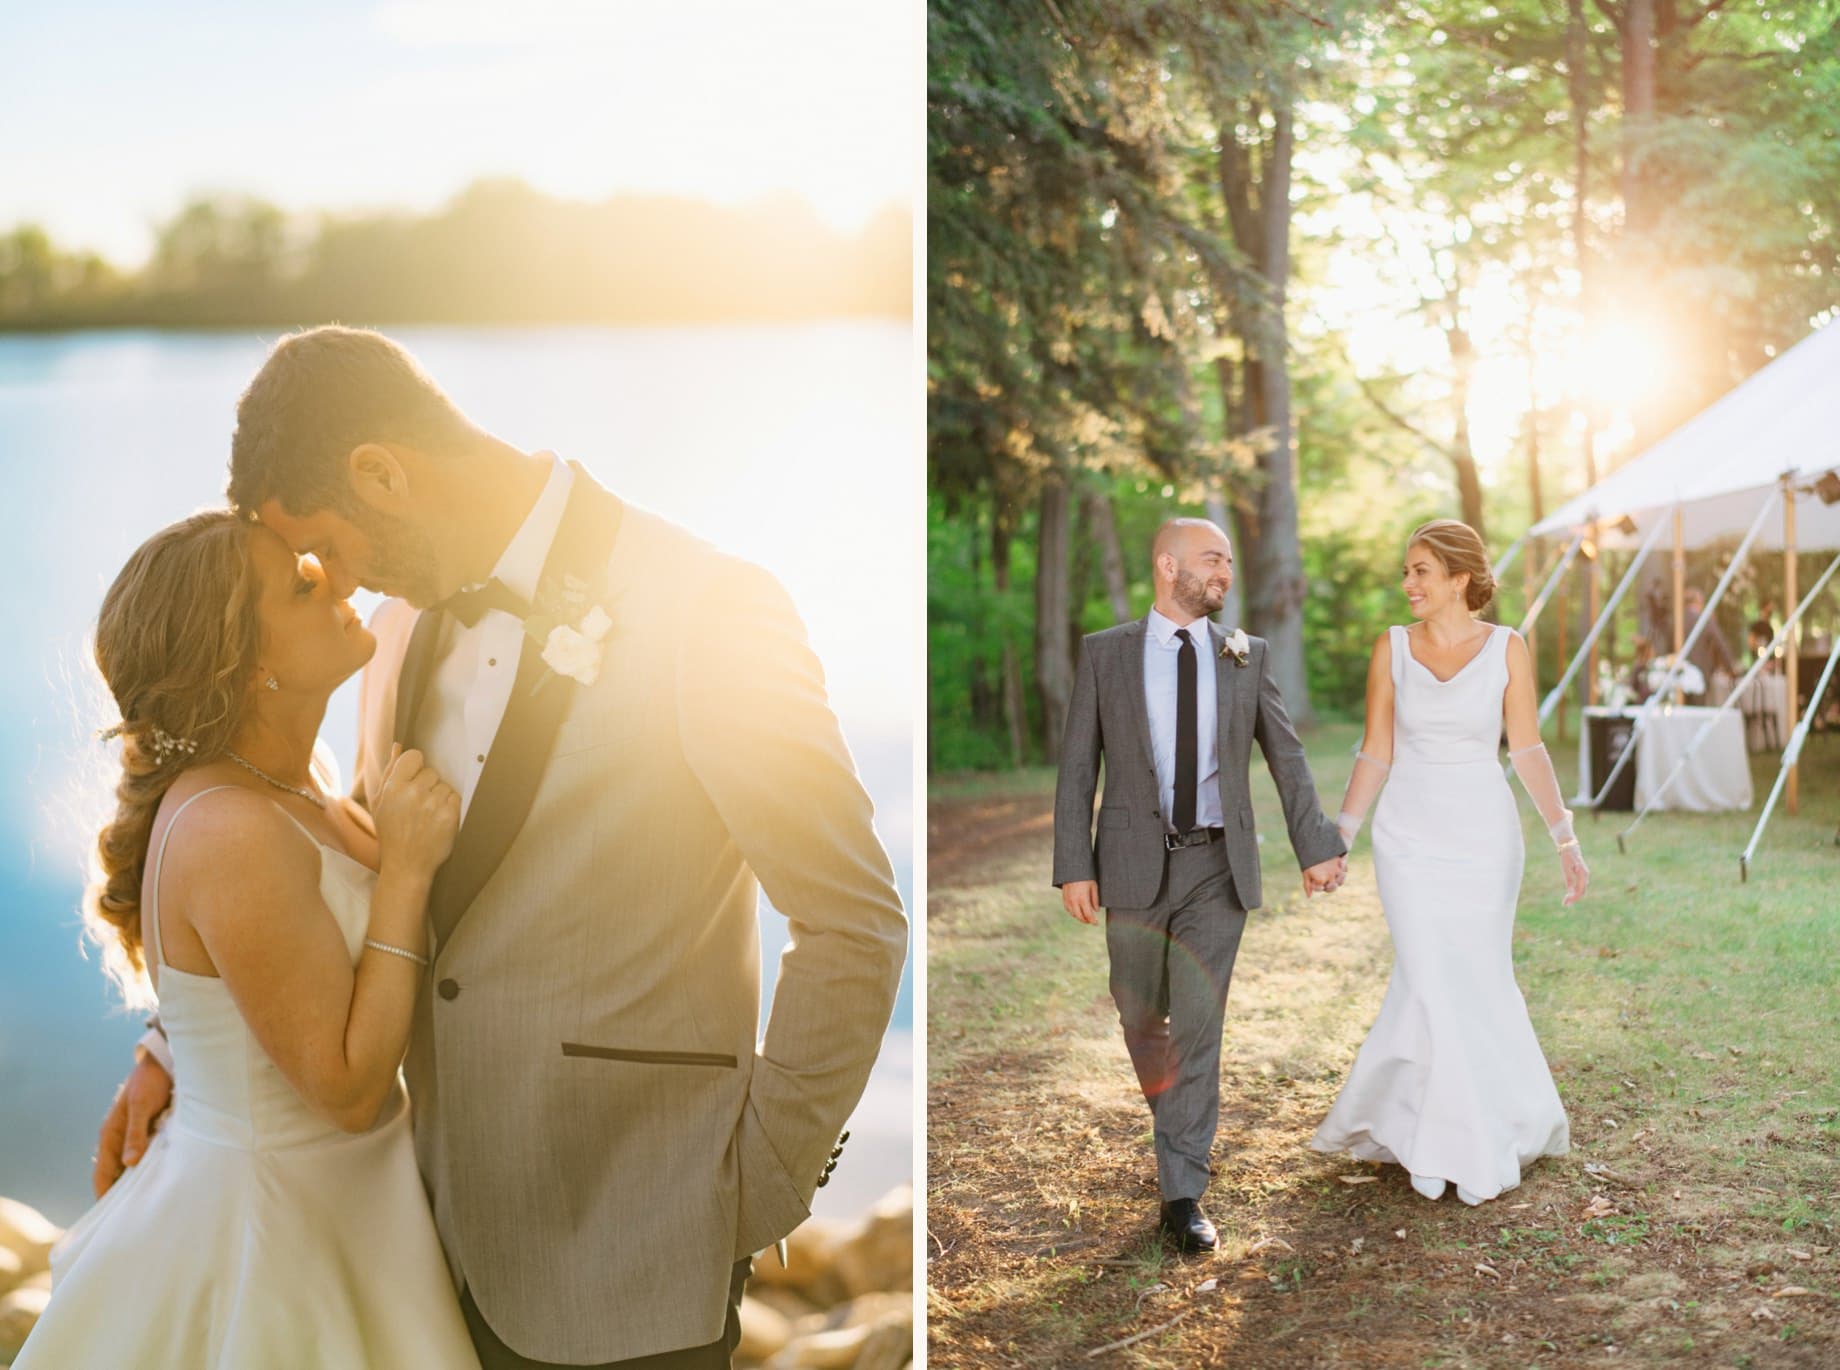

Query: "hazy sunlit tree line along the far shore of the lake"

xmin=0 ymin=180 xmax=913 ymax=329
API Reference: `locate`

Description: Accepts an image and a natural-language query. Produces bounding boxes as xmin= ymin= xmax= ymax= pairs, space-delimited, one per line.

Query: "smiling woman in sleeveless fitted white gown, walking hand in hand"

xmin=1310 ymin=519 xmax=1590 ymax=1204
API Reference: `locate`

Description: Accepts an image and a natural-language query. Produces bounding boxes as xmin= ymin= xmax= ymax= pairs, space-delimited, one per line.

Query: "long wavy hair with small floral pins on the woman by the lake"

xmin=83 ymin=509 xmax=261 ymax=1002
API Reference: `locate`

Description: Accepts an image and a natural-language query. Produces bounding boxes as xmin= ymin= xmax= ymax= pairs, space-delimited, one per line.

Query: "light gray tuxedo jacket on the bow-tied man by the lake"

xmin=359 ymin=467 xmax=907 ymax=1364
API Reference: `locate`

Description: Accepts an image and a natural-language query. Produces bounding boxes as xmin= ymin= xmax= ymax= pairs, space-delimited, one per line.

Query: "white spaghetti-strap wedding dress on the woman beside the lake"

xmin=13 ymin=791 xmax=478 ymax=1370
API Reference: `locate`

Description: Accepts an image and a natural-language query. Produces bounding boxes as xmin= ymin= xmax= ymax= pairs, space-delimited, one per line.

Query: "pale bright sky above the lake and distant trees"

xmin=0 ymin=0 xmax=924 ymax=265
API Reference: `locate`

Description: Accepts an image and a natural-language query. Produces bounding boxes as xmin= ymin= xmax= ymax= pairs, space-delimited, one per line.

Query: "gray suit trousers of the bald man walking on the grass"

xmin=1106 ymin=842 xmax=1246 ymax=1201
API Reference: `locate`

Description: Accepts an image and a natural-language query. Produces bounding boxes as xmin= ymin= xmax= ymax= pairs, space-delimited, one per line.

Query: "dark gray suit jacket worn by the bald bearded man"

xmin=1054 ymin=616 xmax=1347 ymax=908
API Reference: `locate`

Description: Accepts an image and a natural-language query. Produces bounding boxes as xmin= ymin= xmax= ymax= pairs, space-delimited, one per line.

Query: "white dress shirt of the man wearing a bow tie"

xmin=416 ymin=452 xmax=574 ymax=818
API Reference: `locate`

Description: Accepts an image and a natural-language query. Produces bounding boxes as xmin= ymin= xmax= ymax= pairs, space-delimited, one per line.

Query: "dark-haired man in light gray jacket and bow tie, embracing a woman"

xmin=103 ymin=327 xmax=907 ymax=1370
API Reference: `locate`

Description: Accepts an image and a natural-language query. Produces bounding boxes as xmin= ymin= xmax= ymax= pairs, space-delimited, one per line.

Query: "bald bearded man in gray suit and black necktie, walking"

xmin=1054 ymin=519 xmax=1347 ymax=1250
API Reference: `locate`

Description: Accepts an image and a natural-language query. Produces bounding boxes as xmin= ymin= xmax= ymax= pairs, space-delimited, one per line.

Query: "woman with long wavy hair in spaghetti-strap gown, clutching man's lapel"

xmin=15 ymin=511 xmax=478 ymax=1370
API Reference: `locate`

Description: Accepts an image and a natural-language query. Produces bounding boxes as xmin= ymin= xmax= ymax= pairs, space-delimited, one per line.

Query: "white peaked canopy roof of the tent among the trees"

xmin=1531 ymin=324 xmax=1840 ymax=552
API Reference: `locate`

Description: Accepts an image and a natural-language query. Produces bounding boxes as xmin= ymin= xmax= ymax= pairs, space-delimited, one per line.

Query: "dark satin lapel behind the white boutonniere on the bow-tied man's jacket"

xmin=428 ymin=462 xmax=624 ymax=949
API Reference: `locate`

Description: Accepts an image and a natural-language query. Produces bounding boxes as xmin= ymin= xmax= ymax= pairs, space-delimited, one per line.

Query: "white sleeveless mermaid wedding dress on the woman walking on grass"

xmin=1310 ymin=627 xmax=1570 ymax=1203
